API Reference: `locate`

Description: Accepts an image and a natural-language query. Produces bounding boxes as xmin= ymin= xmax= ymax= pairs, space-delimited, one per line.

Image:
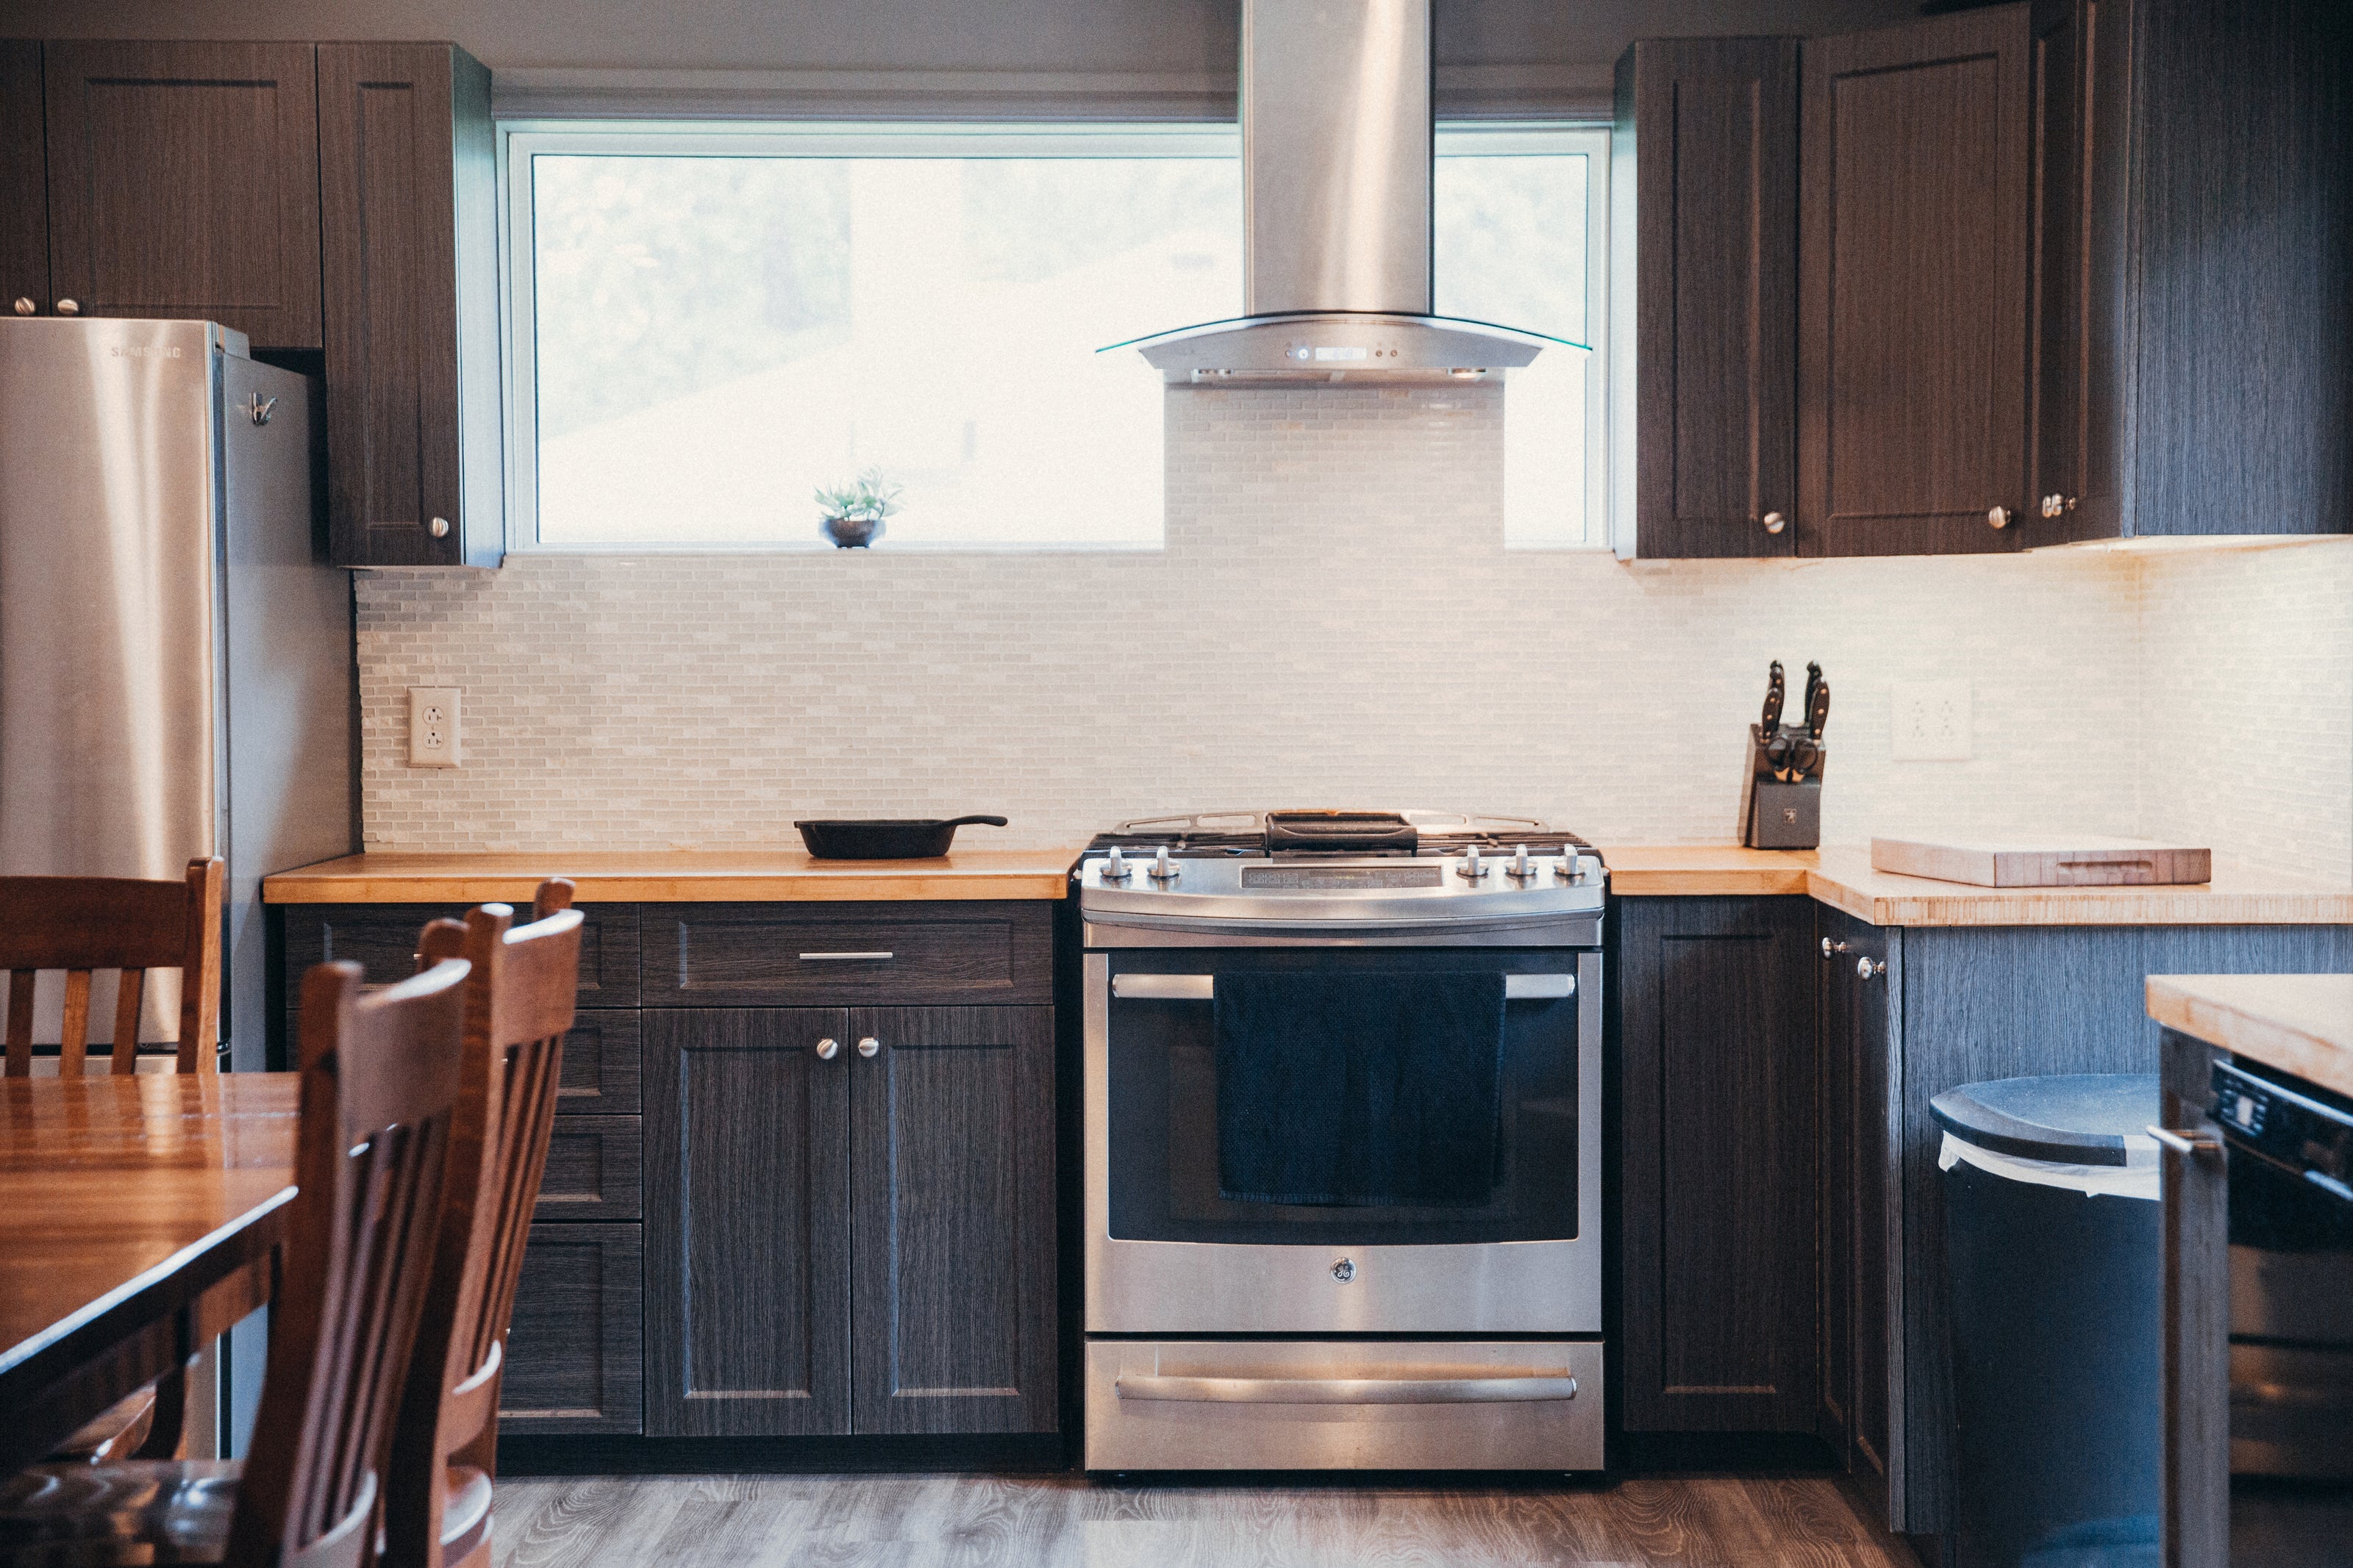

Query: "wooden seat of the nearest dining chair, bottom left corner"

xmin=0 ymin=1460 xmax=243 ymax=1568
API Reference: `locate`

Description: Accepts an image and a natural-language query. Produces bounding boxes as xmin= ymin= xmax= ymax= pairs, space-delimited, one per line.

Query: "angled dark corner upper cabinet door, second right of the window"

xmin=1798 ymin=4 xmax=2028 ymax=555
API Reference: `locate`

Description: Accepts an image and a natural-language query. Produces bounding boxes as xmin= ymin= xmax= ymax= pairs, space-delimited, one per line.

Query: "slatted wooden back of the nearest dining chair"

xmin=228 ymin=962 xmax=468 ymax=1568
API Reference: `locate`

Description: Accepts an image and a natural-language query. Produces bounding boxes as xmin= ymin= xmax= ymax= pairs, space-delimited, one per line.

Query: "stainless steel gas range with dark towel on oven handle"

xmin=1073 ymin=811 xmax=1607 ymax=1469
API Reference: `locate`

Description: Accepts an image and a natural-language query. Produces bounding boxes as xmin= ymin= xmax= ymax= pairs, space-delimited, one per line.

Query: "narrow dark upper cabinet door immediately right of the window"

xmin=1619 ymin=37 xmax=1798 ymax=557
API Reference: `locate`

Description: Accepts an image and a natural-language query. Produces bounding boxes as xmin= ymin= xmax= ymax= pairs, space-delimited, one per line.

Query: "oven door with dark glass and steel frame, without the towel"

xmin=1085 ymin=948 xmax=1602 ymax=1333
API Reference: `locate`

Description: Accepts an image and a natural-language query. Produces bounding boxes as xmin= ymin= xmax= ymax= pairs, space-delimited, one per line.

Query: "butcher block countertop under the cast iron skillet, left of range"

xmin=261 ymin=844 xmax=1078 ymax=903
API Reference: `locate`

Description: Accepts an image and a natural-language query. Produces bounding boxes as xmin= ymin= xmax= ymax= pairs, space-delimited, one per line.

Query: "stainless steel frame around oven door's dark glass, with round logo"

xmin=1082 ymin=952 xmax=1602 ymax=1335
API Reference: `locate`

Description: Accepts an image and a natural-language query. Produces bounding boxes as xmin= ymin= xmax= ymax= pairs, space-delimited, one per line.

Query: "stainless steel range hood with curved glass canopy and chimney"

xmin=1104 ymin=0 xmax=1565 ymax=385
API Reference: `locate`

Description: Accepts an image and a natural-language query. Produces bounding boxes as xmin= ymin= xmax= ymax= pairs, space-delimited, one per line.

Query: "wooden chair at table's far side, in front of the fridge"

xmin=0 ymin=858 xmax=226 ymax=1079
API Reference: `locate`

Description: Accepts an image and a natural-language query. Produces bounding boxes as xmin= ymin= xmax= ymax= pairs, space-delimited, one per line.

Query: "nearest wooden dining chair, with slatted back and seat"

xmin=0 ymin=962 xmax=466 ymax=1568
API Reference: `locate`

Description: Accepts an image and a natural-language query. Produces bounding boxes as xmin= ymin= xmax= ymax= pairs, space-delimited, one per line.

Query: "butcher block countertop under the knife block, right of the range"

xmin=1602 ymin=844 xmax=2353 ymax=926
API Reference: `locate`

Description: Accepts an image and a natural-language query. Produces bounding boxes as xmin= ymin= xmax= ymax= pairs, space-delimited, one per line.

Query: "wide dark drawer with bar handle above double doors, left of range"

xmin=643 ymin=901 xmax=1054 ymax=1006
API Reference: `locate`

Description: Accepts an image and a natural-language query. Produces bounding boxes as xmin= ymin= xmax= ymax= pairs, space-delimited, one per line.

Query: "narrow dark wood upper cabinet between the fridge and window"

xmin=318 ymin=43 xmax=506 ymax=567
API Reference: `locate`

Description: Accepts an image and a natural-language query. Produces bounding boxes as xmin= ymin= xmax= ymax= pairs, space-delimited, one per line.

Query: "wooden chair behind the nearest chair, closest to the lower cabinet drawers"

xmin=384 ymin=879 xmax=581 ymax=1568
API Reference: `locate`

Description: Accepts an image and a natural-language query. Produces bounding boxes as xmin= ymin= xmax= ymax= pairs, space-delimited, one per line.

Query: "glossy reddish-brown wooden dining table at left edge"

xmin=0 ymin=1072 xmax=301 ymax=1476
